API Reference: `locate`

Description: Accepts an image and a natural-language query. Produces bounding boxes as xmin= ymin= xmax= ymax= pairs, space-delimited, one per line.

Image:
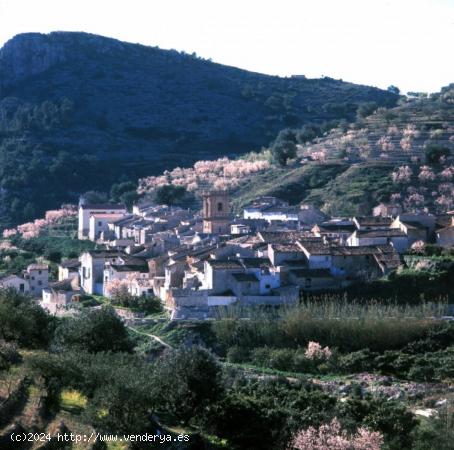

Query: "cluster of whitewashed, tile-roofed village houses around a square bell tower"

xmin=0 ymin=190 xmax=454 ymax=320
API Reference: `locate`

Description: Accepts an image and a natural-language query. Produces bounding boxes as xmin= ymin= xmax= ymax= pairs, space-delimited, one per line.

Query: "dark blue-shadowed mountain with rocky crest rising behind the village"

xmin=0 ymin=32 xmax=397 ymax=226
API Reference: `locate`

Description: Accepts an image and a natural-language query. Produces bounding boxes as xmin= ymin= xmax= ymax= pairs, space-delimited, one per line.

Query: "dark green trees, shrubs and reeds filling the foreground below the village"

xmin=0 ymin=291 xmax=454 ymax=450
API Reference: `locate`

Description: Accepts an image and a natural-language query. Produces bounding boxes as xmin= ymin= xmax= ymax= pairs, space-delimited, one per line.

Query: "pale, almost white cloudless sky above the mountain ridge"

xmin=0 ymin=0 xmax=454 ymax=92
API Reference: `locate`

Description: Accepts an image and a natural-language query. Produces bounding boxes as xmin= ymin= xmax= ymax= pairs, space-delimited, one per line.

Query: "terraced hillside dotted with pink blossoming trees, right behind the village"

xmin=233 ymin=85 xmax=454 ymax=215
